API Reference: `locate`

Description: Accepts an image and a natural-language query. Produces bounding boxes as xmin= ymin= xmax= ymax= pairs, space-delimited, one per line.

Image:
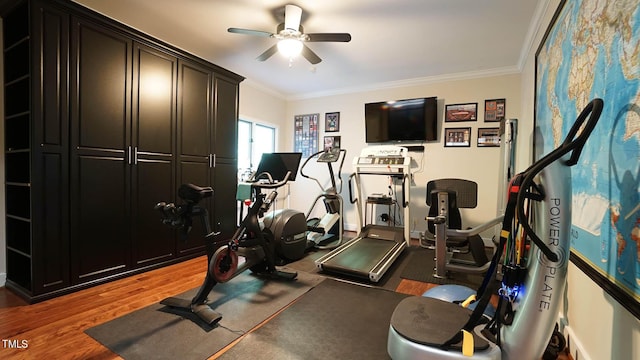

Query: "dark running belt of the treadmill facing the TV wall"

xmin=325 ymin=238 xmax=397 ymax=273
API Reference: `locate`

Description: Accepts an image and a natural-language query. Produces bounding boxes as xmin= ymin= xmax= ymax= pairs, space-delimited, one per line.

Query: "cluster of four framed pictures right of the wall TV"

xmin=444 ymin=99 xmax=506 ymax=148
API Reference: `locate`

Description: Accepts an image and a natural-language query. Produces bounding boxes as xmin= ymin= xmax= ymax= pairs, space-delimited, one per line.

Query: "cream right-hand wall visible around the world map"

xmin=519 ymin=0 xmax=640 ymax=360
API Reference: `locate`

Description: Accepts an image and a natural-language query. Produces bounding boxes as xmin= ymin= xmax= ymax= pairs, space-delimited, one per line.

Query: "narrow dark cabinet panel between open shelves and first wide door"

xmin=29 ymin=3 xmax=70 ymax=294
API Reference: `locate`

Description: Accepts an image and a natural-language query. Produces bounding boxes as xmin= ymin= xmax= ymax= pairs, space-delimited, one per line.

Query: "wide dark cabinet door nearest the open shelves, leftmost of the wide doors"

xmin=70 ymin=19 xmax=132 ymax=283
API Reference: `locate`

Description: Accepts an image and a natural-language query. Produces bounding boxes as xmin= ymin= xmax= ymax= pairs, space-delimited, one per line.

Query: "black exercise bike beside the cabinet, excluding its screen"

xmin=155 ymin=157 xmax=304 ymax=325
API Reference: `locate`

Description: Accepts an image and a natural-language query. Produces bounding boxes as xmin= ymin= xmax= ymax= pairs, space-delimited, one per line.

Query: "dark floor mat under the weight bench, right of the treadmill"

xmin=400 ymin=247 xmax=490 ymax=290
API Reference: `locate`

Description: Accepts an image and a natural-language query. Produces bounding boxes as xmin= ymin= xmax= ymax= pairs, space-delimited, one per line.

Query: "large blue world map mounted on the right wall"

xmin=535 ymin=0 xmax=640 ymax=316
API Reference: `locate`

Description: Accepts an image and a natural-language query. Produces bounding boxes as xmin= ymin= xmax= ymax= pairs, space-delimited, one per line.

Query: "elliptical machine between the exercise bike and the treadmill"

xmin=300 ymin=148 xmax=347 ymax=249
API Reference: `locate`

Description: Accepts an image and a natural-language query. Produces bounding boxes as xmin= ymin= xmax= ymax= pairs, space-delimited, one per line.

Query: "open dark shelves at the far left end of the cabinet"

xmin=3 ymin=2 xmax=32 ymax=288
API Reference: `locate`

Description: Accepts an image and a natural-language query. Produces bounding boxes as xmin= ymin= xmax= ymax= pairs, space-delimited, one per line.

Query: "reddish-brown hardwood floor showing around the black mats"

xmin=0 ymin=256 xmax=568 ymax=360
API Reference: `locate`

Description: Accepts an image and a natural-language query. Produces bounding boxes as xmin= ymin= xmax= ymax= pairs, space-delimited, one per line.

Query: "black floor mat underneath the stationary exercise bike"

xmin=85 ymin=269 xmax=325 ymax=360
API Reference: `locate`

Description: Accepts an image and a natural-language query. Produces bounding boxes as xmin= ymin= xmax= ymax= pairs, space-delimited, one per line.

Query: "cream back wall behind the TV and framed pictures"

xmin=282 ymin=74 xmax=521 ymax=236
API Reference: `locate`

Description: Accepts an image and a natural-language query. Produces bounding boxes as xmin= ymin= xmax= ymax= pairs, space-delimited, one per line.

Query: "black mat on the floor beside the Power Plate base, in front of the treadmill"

xmin=220 ymin=279 xmax=408 ymax=360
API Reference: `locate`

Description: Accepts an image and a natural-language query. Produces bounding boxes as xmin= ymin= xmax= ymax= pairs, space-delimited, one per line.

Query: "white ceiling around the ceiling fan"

xmin=74 ymin=0 xmax=547 ymax=98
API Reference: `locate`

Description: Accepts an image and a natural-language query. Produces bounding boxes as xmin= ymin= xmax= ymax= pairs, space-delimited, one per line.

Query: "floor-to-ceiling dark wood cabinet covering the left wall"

xmin=0 ymin=0 xmax=243 ymax=301
